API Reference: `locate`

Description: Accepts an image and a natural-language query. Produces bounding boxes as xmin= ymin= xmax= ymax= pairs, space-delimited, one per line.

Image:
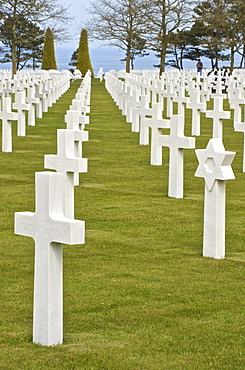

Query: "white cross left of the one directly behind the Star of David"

xmin=186 ymin=89 xmax=206 ymax=136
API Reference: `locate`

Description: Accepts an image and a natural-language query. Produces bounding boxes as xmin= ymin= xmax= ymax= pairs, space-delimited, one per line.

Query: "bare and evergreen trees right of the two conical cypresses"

xmin=86 ymin=0 xmax=245 ymax=73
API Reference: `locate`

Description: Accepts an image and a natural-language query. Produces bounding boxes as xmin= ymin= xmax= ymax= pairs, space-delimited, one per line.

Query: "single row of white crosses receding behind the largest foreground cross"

xmin=15 ymin=72 xmax=91 ymax=346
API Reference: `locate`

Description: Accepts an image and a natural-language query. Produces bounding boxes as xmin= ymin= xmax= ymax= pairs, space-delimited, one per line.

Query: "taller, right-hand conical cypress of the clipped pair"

xmin=77 ymin=28 xmax=94 ymax=77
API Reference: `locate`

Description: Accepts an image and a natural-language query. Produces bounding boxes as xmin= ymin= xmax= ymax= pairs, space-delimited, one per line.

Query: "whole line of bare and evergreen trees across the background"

xmin=0 ymin=0 xmax=245 ymax=73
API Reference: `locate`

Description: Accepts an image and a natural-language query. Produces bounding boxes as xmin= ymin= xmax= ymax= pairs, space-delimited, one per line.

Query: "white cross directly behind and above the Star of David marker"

xmin=205 ymin=95 xmax=231 ymax=139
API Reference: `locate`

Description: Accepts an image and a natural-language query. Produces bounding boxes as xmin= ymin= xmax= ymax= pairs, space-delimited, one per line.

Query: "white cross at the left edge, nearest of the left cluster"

xmin=0 ymin=97 xmax=18 ymax=152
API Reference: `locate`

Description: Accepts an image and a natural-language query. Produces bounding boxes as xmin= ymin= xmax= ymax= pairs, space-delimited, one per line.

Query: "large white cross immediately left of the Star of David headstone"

xmin=159 ymin=115 xmax=195 ymax=198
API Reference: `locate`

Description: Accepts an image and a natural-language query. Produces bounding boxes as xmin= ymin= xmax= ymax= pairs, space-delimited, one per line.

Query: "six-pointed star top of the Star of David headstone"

xmin=195 ymin=138 xmax=236 ymax=191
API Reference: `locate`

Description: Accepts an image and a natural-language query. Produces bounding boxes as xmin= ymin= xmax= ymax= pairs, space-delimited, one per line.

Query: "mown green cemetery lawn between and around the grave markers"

xmin=0 ymin=79 xmax=245 ymax=370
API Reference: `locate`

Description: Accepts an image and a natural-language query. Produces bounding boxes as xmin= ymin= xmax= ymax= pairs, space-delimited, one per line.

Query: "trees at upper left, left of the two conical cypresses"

xmin=0 ymin=0 xmax=71 ymax=74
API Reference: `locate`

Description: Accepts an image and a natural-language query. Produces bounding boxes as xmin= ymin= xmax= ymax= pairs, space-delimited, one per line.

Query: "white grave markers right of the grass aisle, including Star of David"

xmin=106 ymin=71 xmax=237 ymax=259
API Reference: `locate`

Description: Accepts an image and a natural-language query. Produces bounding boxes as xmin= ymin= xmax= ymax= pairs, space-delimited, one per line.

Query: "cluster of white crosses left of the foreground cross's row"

xmin=0 ymin=71 xmax=70 ymax=152
